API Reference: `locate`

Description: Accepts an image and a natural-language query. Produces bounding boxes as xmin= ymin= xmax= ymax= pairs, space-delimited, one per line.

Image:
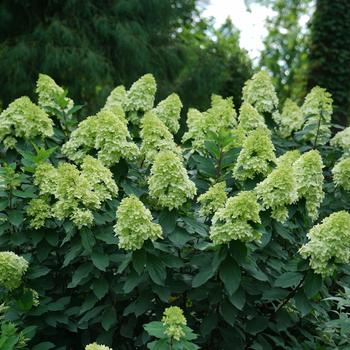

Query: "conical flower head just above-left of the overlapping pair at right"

xmin=233 ymin=129 xmax=276 ymax=181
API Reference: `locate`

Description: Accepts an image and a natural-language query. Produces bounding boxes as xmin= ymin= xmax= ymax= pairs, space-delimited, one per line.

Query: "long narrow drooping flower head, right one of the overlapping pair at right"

xmin=293 ymin=150 xmax=324 ymax=220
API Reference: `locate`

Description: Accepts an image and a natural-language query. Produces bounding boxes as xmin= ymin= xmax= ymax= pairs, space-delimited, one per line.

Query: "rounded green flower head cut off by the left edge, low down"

xmin=0 ymin=252 xmax=28 ymax=290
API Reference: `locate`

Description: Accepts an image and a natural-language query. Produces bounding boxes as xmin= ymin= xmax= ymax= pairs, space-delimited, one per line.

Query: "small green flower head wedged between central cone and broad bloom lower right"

xmin=198 ymin=181 xmax=227 ymax=216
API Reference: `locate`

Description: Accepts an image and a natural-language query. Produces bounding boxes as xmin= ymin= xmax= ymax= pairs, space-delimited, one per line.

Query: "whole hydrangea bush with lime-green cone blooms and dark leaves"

xmin=0 ymin=72 xmax=350 ymax=350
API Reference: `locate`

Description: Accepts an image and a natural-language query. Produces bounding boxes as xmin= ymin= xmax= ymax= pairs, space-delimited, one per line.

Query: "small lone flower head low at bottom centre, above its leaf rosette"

xmin=162 ymin=306 xmax=187 ymax=340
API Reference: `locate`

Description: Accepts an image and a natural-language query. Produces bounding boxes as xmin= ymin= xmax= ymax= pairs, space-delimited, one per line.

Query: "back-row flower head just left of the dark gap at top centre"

xmin=154 ymin=94 xmax=182 ymax=134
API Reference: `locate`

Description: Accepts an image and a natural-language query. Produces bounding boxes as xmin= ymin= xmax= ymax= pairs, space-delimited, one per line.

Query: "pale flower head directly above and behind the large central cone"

xmin=140 ymin=112 xmax=179 ymax=164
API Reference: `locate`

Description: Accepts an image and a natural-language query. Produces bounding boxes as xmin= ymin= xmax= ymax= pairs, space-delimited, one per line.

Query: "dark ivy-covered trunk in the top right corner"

xmin=308 ymin=0 xmax=350 ymax=125
